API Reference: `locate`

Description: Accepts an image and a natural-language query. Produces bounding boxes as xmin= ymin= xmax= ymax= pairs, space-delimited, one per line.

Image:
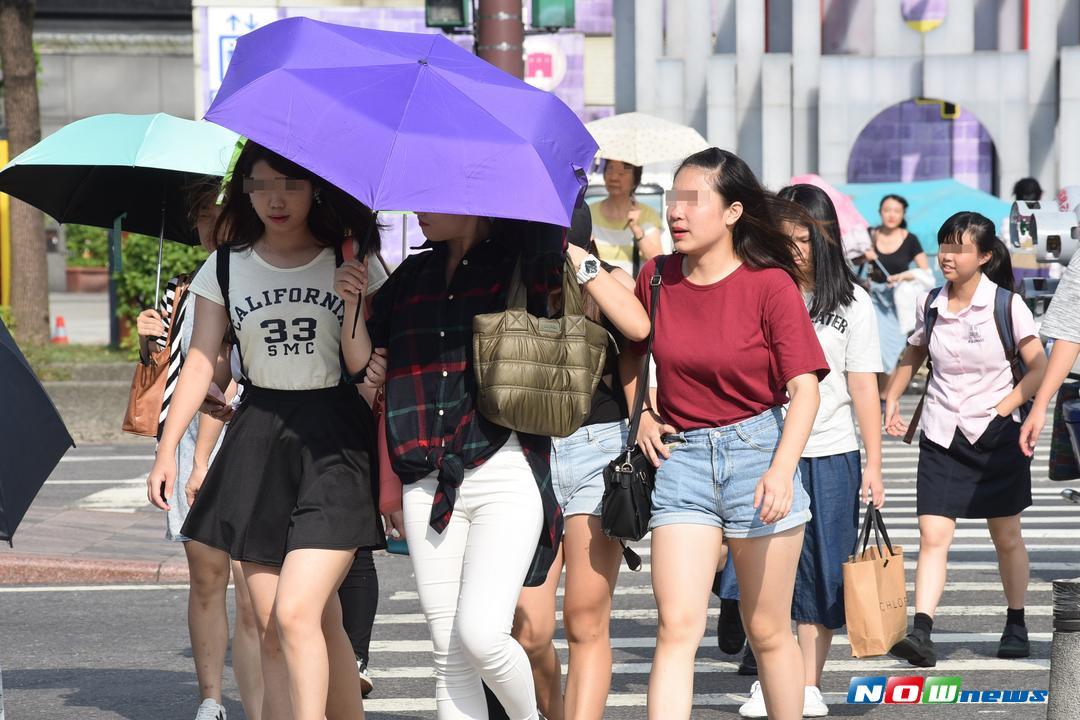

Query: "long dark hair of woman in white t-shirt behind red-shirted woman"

xmin=777 ymin=185 xmax=855 ymax=317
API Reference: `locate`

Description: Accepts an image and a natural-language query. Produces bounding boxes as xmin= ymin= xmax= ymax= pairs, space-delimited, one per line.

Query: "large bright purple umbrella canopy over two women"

xmin=206 ymin=17 xmax=596 ymax=227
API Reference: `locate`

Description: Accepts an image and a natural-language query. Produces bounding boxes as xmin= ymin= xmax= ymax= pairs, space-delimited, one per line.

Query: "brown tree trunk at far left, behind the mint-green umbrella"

xmin=0 ymin=0 xmax=49 ymax=344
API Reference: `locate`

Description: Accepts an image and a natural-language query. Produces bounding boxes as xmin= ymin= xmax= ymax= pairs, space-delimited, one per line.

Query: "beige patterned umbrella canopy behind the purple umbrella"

xmin=585 ymin=112 xmax=708 ymax=165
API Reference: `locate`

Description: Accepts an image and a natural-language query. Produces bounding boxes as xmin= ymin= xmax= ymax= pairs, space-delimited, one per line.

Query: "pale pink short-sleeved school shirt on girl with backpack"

xmin=907 ymin=275 xmax=1037 ymax=448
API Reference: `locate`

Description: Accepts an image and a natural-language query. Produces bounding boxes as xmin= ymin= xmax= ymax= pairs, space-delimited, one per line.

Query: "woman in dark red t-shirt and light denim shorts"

xmin=620 ymin=148 xmax=828 ymax=720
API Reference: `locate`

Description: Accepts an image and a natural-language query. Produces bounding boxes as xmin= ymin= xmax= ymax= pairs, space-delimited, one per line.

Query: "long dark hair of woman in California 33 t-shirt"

xmin=214 ymin=140 xmax=379 ymax=258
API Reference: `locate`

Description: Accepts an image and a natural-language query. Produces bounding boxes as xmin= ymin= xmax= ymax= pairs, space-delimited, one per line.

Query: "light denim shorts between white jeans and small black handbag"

xmin=551 ymin=422 xmax=626 ymax=517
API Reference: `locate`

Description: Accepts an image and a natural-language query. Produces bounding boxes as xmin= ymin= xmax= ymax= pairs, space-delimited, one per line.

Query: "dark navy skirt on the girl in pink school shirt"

xmin=916 ymin=416 xmax=1031 ymax=518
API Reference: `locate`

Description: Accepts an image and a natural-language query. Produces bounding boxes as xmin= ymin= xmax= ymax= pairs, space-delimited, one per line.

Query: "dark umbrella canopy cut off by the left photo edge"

xmin=0 ymin=321 xmax=75 ymax=542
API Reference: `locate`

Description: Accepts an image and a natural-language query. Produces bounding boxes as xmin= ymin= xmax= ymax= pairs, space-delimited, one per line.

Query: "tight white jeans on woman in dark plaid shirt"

xmin=402 ymin=435 xmax=543 ymax=720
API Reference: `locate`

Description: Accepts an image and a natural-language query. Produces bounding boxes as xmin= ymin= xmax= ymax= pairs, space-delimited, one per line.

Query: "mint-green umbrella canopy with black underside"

xmin=0 ymin=113 xmax=238 ymax=245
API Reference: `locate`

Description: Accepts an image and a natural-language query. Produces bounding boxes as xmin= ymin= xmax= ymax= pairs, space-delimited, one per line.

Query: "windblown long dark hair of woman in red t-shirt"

xmin=675 ymin=148 xmax=813 ymax=284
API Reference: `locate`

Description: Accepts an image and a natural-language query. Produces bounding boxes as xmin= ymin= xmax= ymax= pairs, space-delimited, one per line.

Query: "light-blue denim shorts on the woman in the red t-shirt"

xmin=649 ymin=408 xmax=810 ymax=539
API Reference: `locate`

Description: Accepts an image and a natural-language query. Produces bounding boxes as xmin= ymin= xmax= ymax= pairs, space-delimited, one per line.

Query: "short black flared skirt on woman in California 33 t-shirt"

xmin=183 ymin=385 xmax=386 ymax=566
